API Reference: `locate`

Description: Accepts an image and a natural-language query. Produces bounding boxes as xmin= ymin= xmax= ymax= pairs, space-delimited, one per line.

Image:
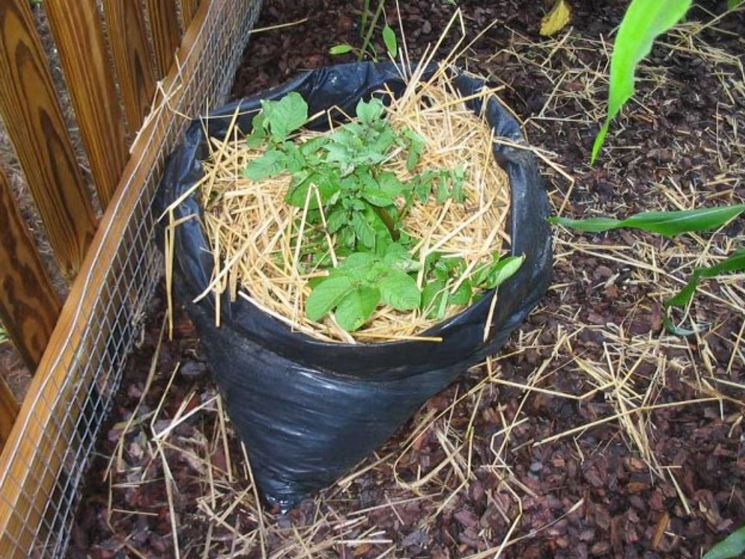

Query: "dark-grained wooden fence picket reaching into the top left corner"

xmin=0 ymin=0 xmax=96 ymax=277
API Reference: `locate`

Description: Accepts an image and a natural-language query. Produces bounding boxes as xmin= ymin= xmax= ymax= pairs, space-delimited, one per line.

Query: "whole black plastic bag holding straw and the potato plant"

xmin=159 ymin=63 xmax=551 ymax=510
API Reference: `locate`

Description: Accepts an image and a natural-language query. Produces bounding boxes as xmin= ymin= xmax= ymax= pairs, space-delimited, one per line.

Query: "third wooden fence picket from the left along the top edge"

xmin=103 ymin=0 xmax=155 ymax=135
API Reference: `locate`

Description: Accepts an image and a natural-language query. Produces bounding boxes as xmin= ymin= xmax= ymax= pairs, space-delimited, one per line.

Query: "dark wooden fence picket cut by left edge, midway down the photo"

xmin=0 ymin=164 xmax=61 ymax=370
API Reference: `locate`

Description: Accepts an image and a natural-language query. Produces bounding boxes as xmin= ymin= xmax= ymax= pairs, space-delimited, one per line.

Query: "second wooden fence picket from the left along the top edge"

xmin=43 ymin=0 xmax=129 ymax=208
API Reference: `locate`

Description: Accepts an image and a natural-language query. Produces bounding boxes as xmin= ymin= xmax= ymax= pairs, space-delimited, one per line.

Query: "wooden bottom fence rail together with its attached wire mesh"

xmin=0 ymin=0 xmax=261 ymax=558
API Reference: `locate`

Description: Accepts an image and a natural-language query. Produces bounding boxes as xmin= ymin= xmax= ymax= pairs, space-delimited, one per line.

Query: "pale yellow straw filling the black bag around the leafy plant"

xmin=195 ymin=68 xmax=509 ymax=343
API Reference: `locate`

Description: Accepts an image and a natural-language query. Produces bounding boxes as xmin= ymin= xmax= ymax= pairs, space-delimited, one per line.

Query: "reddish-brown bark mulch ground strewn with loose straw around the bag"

xmin=70 ymin=0 xmax=745 ymax=558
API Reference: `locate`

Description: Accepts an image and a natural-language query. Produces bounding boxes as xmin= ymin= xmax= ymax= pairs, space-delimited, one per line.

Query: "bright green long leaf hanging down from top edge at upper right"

xmin=590 ymin=0 xmax=691 ymax=163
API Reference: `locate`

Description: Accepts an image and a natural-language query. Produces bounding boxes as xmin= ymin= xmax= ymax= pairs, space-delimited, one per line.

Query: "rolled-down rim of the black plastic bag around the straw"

xmin=156 ymin=62 xmax=552 ymax=382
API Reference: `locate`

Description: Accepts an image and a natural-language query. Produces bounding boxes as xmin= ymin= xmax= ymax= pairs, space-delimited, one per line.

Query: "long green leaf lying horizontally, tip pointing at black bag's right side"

xmin=549 ymin=204 xmax=745 ymax=237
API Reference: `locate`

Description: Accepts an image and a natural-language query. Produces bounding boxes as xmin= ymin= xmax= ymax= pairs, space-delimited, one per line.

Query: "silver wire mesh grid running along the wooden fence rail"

xmin=0 ymin=0 xmax=261 ymax=557
